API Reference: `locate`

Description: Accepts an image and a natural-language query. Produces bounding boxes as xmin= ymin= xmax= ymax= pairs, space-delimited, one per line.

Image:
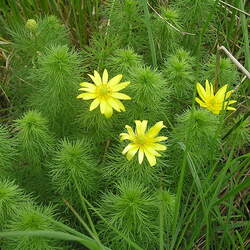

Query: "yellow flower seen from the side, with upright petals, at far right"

xmin=195 ymin=80 xmax=237 ymax=115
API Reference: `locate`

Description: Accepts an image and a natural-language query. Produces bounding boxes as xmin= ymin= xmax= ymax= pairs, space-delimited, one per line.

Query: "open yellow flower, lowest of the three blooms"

xmin=120 ymin=120 xmax=168 ymax=166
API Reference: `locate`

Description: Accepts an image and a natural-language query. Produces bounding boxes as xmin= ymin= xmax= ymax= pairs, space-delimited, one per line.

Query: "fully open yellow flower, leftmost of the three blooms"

xmin=77 ymin=69 xmax=131 ymax=118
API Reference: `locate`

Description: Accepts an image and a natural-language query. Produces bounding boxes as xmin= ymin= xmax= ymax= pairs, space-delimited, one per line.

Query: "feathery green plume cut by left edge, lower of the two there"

xmin=0 ymin=177 xmax=30 ymax=229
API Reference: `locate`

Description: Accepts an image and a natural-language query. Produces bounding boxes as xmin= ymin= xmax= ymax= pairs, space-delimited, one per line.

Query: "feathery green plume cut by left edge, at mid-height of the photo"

xmin=0 ymin=124 xmax=17 ymax=172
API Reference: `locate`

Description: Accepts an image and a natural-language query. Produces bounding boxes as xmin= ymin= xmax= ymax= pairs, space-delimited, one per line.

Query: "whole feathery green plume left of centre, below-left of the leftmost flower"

xmin=16 ymin=111 xmax=54 ymax=167
